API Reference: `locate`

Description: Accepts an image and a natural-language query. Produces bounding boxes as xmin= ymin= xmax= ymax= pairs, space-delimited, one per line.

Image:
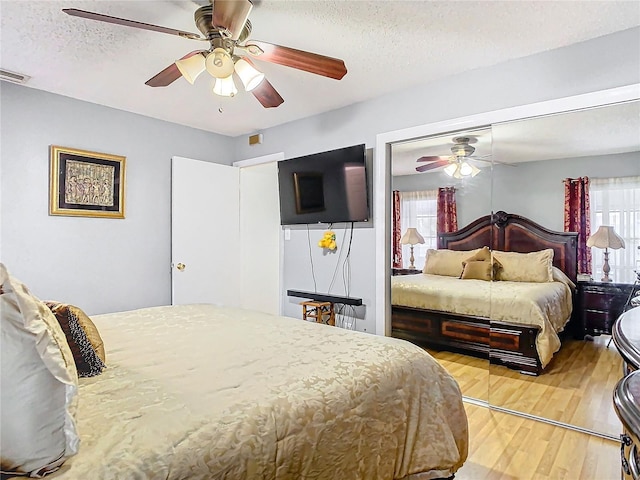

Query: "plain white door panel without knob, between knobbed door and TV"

xmin=240 ymin=161 xmax=281 ymax=315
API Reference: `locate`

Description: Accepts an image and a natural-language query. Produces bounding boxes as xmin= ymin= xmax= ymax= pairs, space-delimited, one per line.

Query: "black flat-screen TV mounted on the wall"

xmin=278 ymin=145 xmax=369 ymax=225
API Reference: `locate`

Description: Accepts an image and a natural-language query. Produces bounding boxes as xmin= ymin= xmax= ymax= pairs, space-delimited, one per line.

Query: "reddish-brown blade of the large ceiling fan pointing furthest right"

xmin=245 ymin=40 xmax=347 ymax=80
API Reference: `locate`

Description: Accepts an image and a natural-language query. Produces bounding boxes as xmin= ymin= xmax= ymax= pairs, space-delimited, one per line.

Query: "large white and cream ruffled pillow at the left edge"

xmin=0 ymin=263 xmax=79 ymax=477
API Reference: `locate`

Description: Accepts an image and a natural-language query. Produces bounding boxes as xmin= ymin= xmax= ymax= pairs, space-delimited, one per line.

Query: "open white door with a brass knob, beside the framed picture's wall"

xmin=171 ymin=157 xmax=241 ymax=306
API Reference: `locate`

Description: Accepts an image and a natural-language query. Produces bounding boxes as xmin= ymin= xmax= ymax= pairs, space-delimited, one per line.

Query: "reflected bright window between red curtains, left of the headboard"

xmin=400 ymin=190 xmax=438 ymax=270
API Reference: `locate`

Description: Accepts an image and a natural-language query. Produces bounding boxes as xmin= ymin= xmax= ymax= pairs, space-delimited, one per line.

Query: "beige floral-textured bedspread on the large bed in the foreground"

xmin=52 ymin=305 xmax=468 ymax=480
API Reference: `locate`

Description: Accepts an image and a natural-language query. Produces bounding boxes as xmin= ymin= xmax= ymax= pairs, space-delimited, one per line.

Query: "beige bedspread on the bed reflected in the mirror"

xmin=391 ymin=274 xmax=572 ymax=368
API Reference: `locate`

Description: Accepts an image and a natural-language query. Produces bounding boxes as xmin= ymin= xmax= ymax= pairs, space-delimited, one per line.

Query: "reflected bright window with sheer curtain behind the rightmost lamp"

xmin=589 ymin=176 xmax=640 ymax=283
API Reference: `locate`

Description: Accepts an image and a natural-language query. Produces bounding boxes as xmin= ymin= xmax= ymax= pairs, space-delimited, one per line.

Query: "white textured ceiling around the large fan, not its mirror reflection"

xmin=0 ymin=0 xmax=640 ymax=136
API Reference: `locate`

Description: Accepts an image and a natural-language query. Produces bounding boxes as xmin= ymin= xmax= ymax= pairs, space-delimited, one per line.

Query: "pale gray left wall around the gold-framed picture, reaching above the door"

xmin=0 ymin=82 xmax=233 ymax=314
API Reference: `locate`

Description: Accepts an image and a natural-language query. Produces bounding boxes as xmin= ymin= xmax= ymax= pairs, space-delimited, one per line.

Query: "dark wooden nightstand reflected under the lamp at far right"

xmin=577 ymin=281 xmax=633 ymax=335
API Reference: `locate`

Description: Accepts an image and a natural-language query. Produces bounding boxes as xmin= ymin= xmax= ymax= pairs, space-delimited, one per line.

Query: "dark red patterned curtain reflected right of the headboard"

xmin=564 ymin=177 xmax=591 ymax=273
